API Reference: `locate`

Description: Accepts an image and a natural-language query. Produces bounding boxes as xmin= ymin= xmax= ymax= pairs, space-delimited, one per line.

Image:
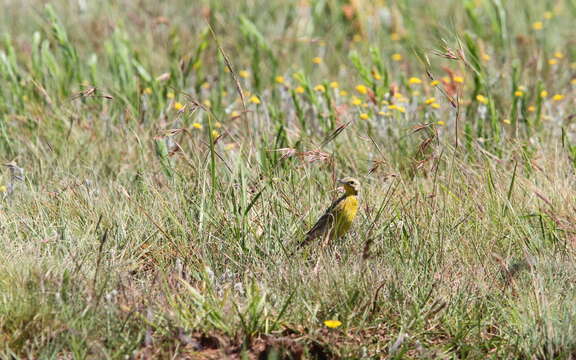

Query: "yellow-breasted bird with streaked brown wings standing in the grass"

xmin=298 ymin=177 xmax=360 ymax=248
